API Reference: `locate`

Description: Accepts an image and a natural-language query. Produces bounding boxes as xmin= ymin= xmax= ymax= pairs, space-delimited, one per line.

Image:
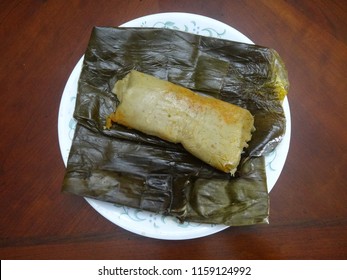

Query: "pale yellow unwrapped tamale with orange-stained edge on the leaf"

xmin=108 ymin=70 xmax=253 ymax=174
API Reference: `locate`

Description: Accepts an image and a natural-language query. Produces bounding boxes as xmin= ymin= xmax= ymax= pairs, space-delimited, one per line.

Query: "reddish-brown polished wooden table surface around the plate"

xmin=0 ymin=0 xmax=347 ymax=259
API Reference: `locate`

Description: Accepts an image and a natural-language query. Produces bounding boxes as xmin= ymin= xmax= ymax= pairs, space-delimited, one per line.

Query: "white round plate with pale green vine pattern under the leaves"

xmin=58 ymin=13 xmax=291 ymax=240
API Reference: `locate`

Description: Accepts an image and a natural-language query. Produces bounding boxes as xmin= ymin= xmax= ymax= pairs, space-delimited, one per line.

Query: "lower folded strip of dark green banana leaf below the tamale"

xmin=63 ymin=125 xmax=269 ymax=225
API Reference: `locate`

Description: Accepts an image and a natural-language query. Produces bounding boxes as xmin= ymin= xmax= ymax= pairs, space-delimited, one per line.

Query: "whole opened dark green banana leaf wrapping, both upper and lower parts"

xmin=63 ymin=27 xmax=288 ymax=225
